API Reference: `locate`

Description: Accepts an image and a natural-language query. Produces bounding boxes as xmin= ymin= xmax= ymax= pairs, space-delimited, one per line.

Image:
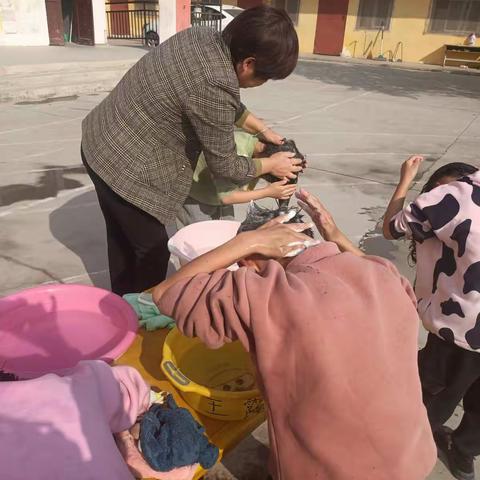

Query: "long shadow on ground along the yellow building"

xmin=295 ymin=61 xmax=480 ymax=99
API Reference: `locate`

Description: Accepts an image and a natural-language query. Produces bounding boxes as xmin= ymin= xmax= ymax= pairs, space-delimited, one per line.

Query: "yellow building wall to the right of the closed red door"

xmin=344 ymin=0 xmax=476 ymax=64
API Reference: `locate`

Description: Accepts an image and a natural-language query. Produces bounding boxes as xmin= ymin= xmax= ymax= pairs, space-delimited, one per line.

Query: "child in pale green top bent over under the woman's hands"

xmin=177 ymin=132 xmax=296 ymax=226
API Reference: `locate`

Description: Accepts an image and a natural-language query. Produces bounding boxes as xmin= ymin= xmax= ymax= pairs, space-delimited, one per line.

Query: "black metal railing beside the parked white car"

xmin=105 ymin=0 xmax=158 ymax=41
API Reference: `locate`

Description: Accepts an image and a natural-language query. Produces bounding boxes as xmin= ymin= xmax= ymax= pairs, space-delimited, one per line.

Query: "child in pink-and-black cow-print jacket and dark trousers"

xmin=383 ymin=156 xmax=480 ymax=480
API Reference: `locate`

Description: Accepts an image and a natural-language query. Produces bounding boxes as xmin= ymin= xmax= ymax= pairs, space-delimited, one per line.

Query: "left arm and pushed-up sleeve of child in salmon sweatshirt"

xmin=153 ymin=217 xmax=310 ymax=350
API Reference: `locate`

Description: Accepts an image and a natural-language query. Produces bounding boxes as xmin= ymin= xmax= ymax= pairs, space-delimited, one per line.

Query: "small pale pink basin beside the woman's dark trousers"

xmin=168 ymin=220 xmax=240 ymax=270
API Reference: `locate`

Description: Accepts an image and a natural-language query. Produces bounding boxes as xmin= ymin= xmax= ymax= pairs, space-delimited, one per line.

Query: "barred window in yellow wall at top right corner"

xmin=429 ymin=0 xmax=480 ymax=35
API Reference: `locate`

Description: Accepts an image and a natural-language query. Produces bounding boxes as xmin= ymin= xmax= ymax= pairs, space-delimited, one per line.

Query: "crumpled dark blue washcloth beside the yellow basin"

xmin=140 ymin=395 xmax=219 ymax=472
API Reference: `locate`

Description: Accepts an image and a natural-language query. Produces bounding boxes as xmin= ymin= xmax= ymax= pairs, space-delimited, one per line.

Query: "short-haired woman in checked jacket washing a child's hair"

xmin=82 ymin=6 xmax=301 ymax=294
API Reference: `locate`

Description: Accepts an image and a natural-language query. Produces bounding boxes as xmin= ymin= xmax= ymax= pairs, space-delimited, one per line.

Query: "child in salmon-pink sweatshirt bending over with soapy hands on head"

xmin=153 ymin=191 xmax=436 ymax=480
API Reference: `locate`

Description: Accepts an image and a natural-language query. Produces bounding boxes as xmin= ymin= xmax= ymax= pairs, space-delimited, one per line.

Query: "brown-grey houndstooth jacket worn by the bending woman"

xmin=82 ymin=28 xmax=258 ymax=224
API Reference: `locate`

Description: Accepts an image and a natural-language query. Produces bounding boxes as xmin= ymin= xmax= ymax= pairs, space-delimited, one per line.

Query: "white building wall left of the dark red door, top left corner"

xmin=0 ymin=0 xmax=49 ymax=45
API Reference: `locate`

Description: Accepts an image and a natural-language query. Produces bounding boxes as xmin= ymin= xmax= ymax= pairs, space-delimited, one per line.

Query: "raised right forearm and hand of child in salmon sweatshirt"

xmin=296 ymin=189 xmax=365 ymax=257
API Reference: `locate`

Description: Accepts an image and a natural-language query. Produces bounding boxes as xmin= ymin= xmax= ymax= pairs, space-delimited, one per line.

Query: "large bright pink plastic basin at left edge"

xmin=0 ymin=285 xmax=138 ymax=378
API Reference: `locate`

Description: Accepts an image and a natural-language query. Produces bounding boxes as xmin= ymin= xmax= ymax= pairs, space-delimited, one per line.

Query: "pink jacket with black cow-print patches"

xmin=390 ymin=172 xmax=480 ymax=352
